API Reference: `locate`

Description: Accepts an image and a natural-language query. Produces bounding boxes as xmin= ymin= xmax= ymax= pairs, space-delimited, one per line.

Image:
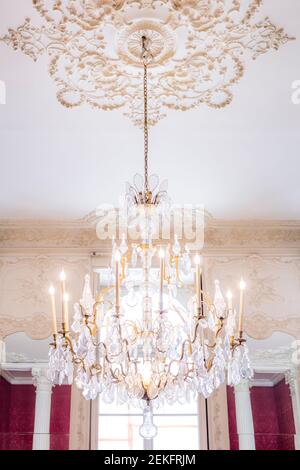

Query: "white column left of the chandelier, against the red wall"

xmin=32 ymin=368 xmax=52 ymax=450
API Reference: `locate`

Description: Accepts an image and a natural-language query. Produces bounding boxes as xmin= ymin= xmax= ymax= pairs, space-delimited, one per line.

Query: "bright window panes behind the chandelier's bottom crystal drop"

xmin=98 ymin=400 xmax=200 ymax=450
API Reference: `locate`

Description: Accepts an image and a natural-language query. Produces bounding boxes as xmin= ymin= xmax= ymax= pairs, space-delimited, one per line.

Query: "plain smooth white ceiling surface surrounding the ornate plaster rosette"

xmin=0 ymin=0 xmax=300 ymax=219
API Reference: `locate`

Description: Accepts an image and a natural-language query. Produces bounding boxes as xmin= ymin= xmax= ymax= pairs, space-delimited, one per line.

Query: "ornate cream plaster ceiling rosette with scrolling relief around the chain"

xmin=1 ymin=0 xmax=292 ymax=125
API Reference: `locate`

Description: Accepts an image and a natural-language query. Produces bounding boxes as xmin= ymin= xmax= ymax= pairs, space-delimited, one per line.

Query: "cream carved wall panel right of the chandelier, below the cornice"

xmin=205 ymin=255 xmax=300 ymax=339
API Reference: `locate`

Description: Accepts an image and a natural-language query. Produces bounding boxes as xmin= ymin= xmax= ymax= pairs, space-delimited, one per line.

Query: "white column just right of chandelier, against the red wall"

xmin=234 ymin=380 xmax=255 ymax=450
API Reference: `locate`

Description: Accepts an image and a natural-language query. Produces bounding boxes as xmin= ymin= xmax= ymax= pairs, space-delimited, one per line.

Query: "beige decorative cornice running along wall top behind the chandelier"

xmin=0 ymin=218 xmax=300 ymax=255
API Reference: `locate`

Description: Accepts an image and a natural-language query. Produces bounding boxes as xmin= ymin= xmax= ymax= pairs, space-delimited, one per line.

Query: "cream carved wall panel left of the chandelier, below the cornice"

xmin=0 ymin=255 xmax=90 ymax=339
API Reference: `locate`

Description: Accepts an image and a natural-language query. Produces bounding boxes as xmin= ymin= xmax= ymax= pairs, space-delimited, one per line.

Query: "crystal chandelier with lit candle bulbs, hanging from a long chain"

xmin=49 ymin=36 xmax=252 ymax=439
